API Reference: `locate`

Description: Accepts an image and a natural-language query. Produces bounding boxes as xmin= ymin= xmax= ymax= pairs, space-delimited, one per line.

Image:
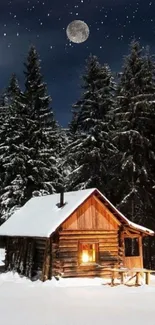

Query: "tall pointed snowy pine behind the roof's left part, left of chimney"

xmin=24 ymin=46 xmax=61 ymax=200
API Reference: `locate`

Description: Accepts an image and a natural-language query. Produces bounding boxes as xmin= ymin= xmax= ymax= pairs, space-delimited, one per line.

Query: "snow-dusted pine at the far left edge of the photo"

xmin=0 ymin=75 xmax=25 ymax=222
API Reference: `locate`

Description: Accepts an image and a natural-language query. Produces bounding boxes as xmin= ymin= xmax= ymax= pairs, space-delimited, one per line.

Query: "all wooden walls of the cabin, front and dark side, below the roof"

xmin=3 ymin=192 xmax=145 ymax=281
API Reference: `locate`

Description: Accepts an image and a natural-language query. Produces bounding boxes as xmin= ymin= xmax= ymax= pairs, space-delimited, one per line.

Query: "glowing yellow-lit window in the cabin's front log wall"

xmin=80 ymin=243 xmax=97 ymax=264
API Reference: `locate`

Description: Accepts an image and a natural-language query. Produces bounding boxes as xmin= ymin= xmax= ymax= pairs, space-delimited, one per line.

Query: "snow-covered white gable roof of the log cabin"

xmin=0 ymin=188 xmax=154 ymax=237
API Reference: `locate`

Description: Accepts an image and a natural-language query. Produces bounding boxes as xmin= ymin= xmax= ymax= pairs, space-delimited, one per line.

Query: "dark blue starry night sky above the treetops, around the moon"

xmin=0 ymin=0 xmax=155 ymax=126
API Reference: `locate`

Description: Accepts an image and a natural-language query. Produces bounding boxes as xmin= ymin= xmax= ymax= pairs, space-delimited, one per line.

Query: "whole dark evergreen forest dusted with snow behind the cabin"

xmin=0 ymin=40 xmax=155 ymax=269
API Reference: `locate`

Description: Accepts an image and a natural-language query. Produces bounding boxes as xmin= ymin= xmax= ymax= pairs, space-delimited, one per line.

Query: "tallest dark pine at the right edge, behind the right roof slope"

xmin=110 ymin=41 xmax=155 ymax=226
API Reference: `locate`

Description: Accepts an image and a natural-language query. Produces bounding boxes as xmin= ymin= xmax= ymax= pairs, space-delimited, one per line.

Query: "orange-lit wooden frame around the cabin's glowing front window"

xmin=78 ymin=240 xmax=99 ymax=267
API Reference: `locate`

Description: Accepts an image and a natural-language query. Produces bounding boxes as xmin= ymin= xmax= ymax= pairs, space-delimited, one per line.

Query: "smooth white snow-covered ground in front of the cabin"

xmin=0 ymin=273 xmax=155 ymax=325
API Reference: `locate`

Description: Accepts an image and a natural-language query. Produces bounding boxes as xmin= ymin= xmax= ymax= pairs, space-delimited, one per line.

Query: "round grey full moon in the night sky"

xmin=66 ymin=20 xmax=89 ymax=43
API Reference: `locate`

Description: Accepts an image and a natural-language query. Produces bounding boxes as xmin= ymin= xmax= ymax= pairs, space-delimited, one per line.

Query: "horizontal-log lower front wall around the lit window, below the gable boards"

xmin=52 ymin=230 xmax=120 ymax=277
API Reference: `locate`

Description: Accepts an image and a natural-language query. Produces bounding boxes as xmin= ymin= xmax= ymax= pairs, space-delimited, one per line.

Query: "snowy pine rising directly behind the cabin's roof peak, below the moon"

xmin=63 ymin=55 xmax=115 ymax=193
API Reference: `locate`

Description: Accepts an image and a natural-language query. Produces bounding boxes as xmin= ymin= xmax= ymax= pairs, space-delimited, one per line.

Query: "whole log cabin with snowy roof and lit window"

xmin=0 ymin=188 xmax=154 ymax=281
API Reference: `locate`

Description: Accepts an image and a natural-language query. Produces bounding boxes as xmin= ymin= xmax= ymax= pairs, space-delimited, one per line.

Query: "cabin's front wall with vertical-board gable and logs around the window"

xmin=52 ymin=196 xmax=123 ymax=277
